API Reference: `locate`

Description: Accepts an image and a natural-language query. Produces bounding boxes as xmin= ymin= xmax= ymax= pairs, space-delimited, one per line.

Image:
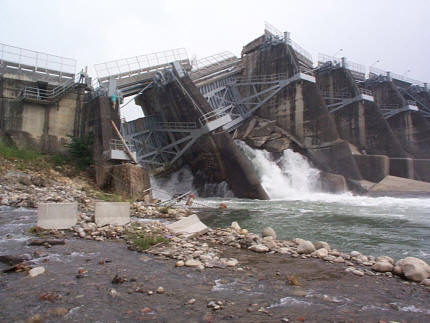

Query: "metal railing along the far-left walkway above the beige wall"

xmin=0 ymin=43 xmax=76 ymax=77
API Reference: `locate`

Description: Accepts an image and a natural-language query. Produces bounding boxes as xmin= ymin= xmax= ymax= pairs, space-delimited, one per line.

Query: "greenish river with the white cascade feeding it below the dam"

xmin=153 ymin=143 xmax=430 ymax=263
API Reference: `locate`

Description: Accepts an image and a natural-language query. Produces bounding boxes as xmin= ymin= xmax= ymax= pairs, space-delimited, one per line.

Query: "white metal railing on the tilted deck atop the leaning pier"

xmin=94 ymin=48 xmax=190 ymax=79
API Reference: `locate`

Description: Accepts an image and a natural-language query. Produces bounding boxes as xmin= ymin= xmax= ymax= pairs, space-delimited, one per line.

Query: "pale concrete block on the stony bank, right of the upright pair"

xmin=95 ymin=202 xmax=130 ymax=227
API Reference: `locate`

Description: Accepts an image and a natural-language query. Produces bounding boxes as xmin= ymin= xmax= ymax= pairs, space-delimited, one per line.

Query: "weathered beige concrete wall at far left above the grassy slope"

xmin=0 ymin=74 xmax=84 ymax=153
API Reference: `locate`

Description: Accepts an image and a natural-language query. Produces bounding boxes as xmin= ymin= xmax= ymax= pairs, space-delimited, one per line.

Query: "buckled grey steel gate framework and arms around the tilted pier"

xmin=123 ymin=72 xmax=315 ymax=167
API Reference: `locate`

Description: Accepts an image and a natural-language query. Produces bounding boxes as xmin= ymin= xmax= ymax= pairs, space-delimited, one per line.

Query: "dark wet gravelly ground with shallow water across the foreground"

xmin=0 ymin=209 xmax=430 ymax=322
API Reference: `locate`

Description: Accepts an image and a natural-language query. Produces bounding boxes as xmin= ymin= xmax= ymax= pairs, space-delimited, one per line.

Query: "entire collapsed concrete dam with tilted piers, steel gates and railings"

xmin=0 ymin=24 xmax=430 ymax=199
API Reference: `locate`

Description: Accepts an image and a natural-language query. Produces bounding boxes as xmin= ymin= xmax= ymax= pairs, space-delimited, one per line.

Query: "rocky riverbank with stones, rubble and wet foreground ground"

xmin=0 ymin=156 xmax=430 ymax=322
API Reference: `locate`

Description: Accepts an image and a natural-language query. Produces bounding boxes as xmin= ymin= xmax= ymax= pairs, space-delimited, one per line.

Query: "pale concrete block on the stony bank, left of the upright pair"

xmin=37 ymin=203 xmax=78 ymax=229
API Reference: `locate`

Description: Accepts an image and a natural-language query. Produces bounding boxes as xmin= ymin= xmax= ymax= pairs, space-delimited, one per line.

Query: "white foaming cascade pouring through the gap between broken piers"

xmin=236 ymin=141 xmax=319 ymax=199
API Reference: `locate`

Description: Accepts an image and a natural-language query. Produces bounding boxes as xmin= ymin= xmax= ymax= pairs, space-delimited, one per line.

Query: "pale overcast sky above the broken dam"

xmin=0 ymin=0 xmax=430 ymax=119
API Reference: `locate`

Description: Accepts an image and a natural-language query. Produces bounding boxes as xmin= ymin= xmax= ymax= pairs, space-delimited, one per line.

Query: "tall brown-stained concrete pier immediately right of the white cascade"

xmin=241 ymin=39 xmax=361 ymax=179
